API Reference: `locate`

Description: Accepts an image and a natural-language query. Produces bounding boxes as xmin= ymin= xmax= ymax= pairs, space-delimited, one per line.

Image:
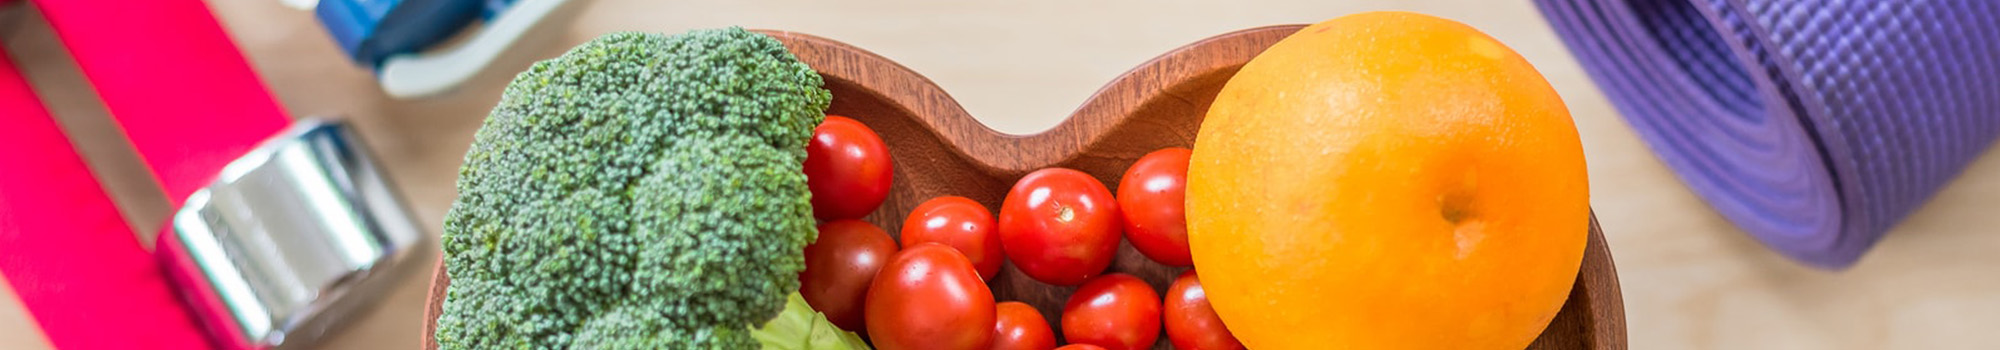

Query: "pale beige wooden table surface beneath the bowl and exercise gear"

xmin=0 ymin=0 xmax=2000 ymax=350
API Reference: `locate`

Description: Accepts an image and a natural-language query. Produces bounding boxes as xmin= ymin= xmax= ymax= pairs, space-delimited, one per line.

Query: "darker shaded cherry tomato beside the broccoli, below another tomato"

xmin=798 ymin=220 xmax=896 ymax=332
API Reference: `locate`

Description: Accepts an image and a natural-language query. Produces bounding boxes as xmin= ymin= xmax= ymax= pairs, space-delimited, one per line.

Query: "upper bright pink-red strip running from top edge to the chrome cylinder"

xmin=34 ymin=0 xmax=292 ymax=202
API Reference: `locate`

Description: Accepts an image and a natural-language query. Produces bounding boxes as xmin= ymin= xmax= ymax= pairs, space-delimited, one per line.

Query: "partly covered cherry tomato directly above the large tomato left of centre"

xmin=902 ymin=196 xmax=1006 ymax=280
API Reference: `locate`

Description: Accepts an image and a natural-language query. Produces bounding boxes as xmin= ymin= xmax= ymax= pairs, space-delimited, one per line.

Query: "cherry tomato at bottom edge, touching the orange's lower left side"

xmin=1166 ymin=270 xmax=1244 ymax=350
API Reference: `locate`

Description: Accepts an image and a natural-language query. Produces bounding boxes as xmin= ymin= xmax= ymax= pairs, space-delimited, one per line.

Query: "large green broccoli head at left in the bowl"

xmin=436 ymin=28 xmax=830 ymax=350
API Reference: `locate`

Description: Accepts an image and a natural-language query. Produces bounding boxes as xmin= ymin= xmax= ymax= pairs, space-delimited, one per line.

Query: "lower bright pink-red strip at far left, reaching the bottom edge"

xmin=0 ymin=54 xmax=210 ymax=350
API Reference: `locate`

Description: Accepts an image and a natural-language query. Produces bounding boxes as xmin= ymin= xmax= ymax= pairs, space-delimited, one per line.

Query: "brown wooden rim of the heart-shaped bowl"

xmin=422 ymin=24 xmax=1626 ymax=350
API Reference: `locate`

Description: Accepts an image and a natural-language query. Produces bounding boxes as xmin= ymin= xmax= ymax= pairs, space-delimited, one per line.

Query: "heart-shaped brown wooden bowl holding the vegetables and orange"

xmin=424 ymin=26 xmax=1626 ymax=350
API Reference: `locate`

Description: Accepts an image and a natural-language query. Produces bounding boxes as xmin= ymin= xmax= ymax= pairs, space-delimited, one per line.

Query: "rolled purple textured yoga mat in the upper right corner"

xmin=1536 ymin=0 xmax=2000 ymax=270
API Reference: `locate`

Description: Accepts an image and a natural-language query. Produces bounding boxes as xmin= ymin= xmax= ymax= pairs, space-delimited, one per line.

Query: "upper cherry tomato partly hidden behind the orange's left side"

xmin=1118 ymin=148 xmax=1194 ymax=266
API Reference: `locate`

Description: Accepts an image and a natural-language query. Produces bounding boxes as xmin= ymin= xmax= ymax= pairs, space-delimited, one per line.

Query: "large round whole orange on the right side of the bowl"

xmin=1188 ymin=12 xmax=1590 ymax=350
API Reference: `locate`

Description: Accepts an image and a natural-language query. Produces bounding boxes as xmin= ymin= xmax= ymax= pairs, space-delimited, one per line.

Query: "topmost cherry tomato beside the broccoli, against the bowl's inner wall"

xmin=806 ymin=116 xmax=896 ymax=220
